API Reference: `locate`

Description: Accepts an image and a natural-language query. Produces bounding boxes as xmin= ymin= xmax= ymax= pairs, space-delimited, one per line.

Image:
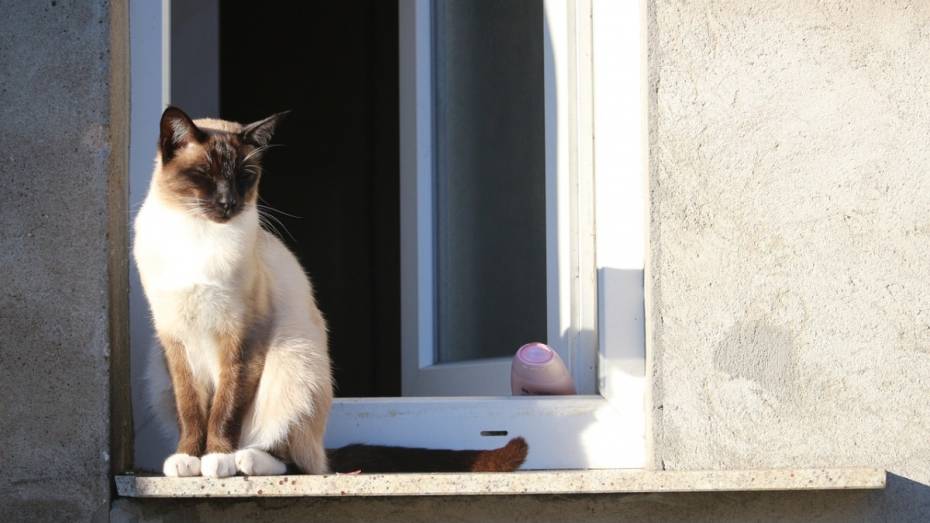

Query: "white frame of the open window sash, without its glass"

xmin=399 ymin=0 xmax=597 ymax=396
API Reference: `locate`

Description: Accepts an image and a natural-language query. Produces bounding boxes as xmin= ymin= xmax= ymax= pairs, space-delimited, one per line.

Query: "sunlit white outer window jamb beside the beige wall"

xmin=592 ymin=0 xmax=648 ymax=410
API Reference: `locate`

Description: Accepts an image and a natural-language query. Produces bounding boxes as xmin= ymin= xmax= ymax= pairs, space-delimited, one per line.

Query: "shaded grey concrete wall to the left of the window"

xmin=0 ymin=0 xmax=126 ymax=521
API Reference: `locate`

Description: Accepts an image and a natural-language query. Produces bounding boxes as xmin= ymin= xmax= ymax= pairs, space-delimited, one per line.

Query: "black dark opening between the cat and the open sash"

xmin=219 ymin=0 xmax=400 ymax=397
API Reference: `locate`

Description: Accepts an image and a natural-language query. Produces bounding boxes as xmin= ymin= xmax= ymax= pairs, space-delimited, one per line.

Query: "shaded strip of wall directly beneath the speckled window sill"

xmin=111 ymin=492 xmax=898 ymax=523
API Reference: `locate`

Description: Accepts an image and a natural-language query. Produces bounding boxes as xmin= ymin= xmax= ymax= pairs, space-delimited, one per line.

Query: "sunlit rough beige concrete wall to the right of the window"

xmin=647 ymin=0 xmax=930 ymax=521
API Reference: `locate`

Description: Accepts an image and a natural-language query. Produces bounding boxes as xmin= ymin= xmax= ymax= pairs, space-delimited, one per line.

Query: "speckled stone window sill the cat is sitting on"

xmin=116 ymin=468 xmax=885 ymax=498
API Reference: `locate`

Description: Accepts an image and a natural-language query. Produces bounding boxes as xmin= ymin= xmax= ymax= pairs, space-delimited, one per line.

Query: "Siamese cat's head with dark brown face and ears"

xmin=156 ymin=107 xmax=287 ymax=223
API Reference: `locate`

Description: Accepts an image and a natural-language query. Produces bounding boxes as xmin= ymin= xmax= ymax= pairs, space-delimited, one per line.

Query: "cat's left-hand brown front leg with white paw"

xmin=159 ymin=335 xmax=207 ymax=477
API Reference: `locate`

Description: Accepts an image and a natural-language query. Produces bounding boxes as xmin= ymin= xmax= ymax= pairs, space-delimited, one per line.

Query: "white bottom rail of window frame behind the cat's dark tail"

xmin=326 ymin=396 xmax=643 ymax=469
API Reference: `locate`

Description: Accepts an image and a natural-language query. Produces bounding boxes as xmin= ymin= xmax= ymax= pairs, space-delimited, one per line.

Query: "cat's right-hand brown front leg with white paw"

xmin=201 ymin=337 xmax=261 ymax=478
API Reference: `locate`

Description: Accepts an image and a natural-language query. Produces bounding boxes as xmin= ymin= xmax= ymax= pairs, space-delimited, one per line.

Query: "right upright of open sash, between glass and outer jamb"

xmin=544 ymin=0 xmax=598 ymax=394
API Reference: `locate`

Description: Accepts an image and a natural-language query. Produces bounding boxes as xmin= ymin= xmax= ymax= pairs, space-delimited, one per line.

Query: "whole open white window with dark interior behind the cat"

xmin=130 ymin=0 xmax=645 ymax=469
